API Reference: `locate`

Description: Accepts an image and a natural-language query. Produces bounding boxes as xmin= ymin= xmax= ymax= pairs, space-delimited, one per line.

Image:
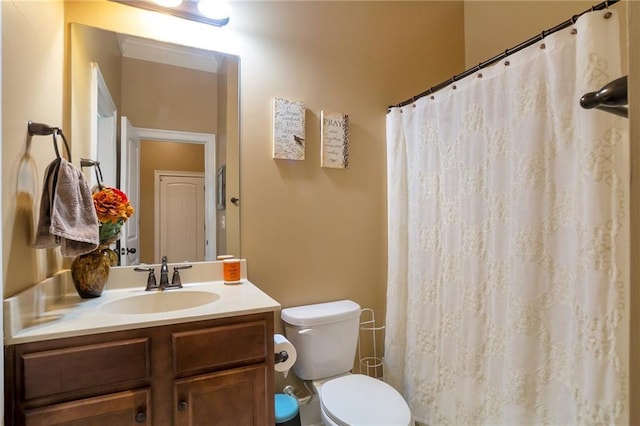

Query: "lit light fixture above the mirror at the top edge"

xmin=111 ymin=0 xmax=231 ymax=27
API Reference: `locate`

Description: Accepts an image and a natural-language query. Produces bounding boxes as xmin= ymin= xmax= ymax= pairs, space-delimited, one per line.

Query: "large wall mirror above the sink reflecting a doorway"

xmin=69 ymin=23 xmax=240 ymax=265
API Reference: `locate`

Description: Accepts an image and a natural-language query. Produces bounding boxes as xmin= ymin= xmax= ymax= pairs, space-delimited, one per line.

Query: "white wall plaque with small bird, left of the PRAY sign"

xmin=273 ymin=98 xmax=306 ymax=160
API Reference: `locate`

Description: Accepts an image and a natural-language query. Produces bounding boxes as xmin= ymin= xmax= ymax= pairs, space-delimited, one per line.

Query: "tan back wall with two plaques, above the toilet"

xmin=234 ymin=2 xmax=464 ymax=321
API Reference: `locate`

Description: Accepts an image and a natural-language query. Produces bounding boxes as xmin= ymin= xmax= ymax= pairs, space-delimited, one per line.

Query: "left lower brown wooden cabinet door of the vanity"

xmin=25 ymin=389 xmax=152 ymax=426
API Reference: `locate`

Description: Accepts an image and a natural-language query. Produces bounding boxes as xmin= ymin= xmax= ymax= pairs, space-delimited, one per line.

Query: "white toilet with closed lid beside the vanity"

xmin=281 ymin=300 xmax=413 ymax=426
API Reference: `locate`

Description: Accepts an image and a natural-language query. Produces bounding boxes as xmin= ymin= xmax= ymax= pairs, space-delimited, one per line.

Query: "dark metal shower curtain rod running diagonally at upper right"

xmin=387 ymin=0 xmax=620 ymax=113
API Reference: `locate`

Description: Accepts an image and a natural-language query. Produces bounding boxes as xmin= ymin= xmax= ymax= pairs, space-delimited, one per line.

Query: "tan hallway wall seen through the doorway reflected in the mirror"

xmin=136 ymin=141 xmax=204 ymax=263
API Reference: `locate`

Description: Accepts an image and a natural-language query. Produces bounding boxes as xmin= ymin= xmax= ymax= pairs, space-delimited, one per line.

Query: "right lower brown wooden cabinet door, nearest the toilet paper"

xmin=174 ymin=365 xmax=273 ymax=426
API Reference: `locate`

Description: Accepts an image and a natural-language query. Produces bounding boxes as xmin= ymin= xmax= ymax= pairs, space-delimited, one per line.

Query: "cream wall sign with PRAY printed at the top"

xmin=320 ymin=111 xmax=349 ymax=169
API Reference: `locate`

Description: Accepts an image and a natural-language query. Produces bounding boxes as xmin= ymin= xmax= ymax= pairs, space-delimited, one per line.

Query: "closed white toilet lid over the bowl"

xmin=320 ymin=374 xmax=411 ymax=426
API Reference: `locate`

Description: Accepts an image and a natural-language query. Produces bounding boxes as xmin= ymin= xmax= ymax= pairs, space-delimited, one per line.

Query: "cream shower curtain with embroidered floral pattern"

xmin=384 ymin=10 xmax=629 ymax=426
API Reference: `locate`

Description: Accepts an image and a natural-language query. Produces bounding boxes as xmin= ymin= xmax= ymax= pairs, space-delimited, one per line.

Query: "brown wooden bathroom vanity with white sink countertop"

xmin=5 ymin=262 xmax=280 ymax=426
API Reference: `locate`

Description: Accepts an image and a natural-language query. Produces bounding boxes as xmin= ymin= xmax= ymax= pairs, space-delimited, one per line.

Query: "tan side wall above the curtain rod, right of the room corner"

xmin=464 ymin=0 xmax=627 ymax=69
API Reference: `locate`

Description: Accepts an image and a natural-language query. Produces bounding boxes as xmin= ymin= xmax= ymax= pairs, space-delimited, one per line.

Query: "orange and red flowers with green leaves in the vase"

xmin=93 ymin=186 xmax=135 ymax=246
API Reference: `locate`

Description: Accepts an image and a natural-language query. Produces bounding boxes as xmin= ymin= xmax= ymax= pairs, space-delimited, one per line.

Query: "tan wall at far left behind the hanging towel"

xmin=0 ymin=1 xmax=64 ymax=297
